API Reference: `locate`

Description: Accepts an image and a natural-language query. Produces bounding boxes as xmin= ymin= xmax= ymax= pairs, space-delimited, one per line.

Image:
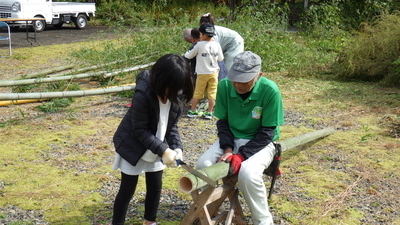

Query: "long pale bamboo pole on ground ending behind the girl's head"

xmin=0 ymin=62 xmax=155 ymax=87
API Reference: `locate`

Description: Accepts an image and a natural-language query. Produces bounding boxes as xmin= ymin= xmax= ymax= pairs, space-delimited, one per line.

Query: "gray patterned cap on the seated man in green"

xmin=228 ymin=51 xmax=261 ymax=83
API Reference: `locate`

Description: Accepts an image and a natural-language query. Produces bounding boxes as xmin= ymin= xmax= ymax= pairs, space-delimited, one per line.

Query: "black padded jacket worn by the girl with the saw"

xmin=113 ymin=70 xmax=182 ymax=166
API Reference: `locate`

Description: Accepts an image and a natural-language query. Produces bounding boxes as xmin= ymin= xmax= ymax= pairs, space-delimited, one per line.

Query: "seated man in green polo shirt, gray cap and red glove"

xmin=196 ymin=51 xmax=284 ymax=225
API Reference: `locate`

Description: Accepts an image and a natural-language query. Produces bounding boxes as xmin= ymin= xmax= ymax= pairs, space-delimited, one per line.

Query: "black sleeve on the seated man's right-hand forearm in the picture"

xmin=239 ymin=127 xmax=276 ymax=159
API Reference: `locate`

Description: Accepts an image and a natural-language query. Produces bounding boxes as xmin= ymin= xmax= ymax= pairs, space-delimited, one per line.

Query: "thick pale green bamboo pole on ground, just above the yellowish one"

xmin=0 ymin=86 xmax=135 ymax=100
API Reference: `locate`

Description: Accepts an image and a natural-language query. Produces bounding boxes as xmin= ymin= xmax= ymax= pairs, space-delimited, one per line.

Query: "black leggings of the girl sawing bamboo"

xmin=112 ymin=170 xmax=163 ymax=225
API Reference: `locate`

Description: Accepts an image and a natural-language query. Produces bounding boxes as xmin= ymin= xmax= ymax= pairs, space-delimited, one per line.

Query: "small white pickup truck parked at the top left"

xmin=0 ymin=0 xmax=96 ymax=32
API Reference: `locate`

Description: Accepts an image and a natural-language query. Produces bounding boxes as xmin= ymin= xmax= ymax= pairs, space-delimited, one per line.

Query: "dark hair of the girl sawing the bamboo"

xmin=150 ymin=54 xmax=194 ymax=103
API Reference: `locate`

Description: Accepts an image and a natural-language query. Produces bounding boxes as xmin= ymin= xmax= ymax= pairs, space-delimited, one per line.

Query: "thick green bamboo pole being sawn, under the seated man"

xmin=178 ymin=127 xmax=335 ymax=193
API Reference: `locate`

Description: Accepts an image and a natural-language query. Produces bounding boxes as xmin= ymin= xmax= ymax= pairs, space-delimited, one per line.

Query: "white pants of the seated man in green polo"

xmin=196 ymin=139 xmax=275 ymax=225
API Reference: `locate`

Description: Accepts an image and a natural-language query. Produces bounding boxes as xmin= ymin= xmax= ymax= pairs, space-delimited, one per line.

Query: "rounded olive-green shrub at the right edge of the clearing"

xmin=334 ymin=13 xmax=400 ymax=86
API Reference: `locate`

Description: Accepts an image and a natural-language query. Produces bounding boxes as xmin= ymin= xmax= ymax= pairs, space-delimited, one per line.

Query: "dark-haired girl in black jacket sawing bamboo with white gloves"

xmin=112 ymin=54 xmax=194 ymax=225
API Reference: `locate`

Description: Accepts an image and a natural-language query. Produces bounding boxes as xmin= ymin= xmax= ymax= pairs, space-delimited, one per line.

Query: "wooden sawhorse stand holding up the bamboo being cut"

xmin=180 ymin=176 xmax=246 ymax=225
